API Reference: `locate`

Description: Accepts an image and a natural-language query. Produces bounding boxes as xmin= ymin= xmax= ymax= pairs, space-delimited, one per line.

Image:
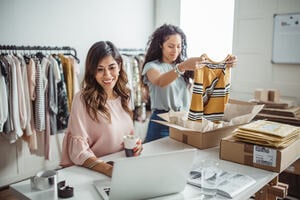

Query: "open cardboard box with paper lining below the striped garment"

xmin=153 ymin=99 xmax=263 ymax=149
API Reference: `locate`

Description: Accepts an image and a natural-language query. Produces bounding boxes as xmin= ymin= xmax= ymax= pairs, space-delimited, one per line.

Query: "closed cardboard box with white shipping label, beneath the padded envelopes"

xmin=220 ymin=136 xmax=300 ymax=173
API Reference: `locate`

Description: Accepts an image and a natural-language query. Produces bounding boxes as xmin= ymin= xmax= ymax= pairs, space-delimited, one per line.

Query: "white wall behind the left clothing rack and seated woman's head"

xmin=0 ymin=0 xmax=155 ymax=187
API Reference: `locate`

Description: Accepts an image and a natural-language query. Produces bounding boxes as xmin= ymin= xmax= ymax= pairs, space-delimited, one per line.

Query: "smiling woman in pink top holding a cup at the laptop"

xmin=61 ymin=41 xmax=142 ymax=176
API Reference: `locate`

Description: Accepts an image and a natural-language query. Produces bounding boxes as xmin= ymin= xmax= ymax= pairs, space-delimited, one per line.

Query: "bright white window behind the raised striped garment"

xmin=180 ymin=0 xmax=234 ymax=61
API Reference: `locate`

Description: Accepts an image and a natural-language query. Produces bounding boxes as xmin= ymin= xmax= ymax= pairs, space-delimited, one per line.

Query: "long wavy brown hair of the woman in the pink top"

xmin=81 ymin=41 xmax=132 ymax=122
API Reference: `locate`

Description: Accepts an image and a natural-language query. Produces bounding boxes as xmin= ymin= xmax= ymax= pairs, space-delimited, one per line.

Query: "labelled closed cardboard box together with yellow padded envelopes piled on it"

xmin=220 ymin=121 xmax=300 ymax=173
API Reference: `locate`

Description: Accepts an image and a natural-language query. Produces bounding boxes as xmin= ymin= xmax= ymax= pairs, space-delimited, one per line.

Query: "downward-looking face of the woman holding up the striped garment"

xmin=162 ymin=34 xmax=181 ymax=63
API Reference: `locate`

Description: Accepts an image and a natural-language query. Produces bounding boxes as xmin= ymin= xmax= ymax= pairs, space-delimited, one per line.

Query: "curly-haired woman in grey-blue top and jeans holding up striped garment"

xmin=142 ymin=24 xmax=201 ymax=142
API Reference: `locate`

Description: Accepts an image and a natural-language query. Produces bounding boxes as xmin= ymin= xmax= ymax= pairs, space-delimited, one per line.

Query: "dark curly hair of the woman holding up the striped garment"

xmin=143 ymin=24 xmax=194 ymax=85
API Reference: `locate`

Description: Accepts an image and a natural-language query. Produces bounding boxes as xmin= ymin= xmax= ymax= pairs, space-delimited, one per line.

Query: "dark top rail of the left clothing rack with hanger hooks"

xmin=0 ymin=45 xmax=80 ymax=63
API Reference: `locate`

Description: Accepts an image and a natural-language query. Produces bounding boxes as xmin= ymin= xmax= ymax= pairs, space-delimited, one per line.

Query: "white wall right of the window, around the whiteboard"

xmin=231 ymin=0 xmax=300 ymax=104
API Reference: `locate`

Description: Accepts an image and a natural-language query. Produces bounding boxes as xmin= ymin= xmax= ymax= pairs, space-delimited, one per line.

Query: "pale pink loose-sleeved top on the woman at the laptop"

xmin=60 ymin=92 xmax=133 ymax=167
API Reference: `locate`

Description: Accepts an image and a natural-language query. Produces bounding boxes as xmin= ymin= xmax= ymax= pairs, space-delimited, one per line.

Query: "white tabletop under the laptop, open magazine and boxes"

xmin=10 ymin=137 xmax=278 ymax=200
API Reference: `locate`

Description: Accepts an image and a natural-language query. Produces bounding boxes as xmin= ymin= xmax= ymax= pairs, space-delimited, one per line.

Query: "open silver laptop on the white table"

xmin=94 ymin=148 xmax=196 ymax=200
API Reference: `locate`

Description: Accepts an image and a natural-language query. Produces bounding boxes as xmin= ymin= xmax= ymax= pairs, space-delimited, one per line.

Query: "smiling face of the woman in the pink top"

xmin=95 ymin=55 xmax=120 ymax=99
